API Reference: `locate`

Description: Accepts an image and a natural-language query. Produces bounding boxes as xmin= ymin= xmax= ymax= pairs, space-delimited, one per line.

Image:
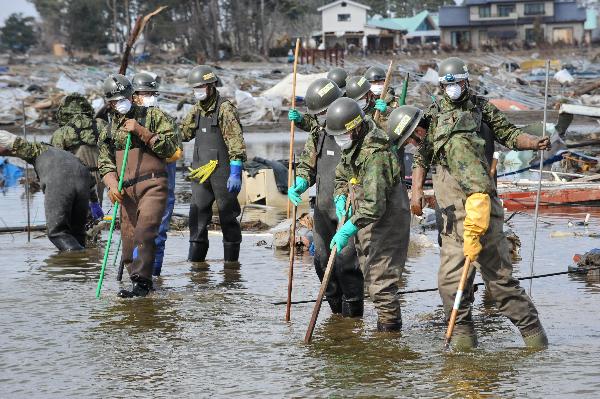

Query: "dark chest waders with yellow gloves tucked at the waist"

xmin=188 ymin=97 xmax=242 ymax=262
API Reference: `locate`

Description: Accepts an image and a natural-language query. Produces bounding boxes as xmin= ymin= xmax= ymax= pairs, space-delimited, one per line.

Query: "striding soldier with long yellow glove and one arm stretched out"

xmin=411 ymin=57 xmax=549 ymax=348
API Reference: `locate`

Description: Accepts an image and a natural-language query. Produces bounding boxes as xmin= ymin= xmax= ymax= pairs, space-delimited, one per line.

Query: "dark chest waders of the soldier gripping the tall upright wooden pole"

xmin=313 ymin=130 xmax=364 ymax=317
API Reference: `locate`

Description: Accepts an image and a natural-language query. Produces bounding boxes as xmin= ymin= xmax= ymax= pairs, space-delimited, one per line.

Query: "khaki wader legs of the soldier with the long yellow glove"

xmin=433 ymin=166 xmax=540 ymax=334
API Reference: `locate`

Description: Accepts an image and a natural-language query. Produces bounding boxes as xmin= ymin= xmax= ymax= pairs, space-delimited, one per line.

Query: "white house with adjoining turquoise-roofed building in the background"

xmin=317 ymin=0 xmax=440 ymax=51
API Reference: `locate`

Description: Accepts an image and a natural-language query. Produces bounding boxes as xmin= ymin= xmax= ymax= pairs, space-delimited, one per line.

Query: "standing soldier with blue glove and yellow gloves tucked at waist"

xmin=181 ymin=65 xmax=246 ymax=264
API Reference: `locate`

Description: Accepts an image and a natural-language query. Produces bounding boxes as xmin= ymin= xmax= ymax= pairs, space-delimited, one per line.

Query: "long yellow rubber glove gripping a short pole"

xmin=463 ymin=193 xmax=491 ymax=262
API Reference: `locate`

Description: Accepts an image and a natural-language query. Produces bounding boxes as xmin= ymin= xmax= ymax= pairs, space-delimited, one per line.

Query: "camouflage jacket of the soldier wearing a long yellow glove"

xmin=413 ymin=95 xmax=523 ymax=196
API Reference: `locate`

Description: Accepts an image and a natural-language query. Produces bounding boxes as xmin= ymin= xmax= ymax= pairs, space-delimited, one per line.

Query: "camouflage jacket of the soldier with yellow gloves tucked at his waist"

xmin=181 ymin=92 xmax=246 ymax=162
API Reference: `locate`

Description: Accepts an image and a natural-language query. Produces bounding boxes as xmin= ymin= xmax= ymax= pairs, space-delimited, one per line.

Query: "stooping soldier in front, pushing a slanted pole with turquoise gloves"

xmin=326 ymin=98 xmax=410 ymax=331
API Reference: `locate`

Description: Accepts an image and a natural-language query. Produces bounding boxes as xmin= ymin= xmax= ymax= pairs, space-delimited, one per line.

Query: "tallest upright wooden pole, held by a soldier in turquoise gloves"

xmin=285 ymin=39 xmax=300 ymax=321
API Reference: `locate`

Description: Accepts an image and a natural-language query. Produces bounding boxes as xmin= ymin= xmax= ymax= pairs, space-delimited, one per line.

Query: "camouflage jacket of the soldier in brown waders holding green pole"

xmin=98 ymin=105 xmax=178 ymax=177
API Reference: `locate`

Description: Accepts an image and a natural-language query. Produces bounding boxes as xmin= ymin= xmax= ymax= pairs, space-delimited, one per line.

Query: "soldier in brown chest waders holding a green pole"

xmin=98 ymin=75 xmax=177 ymax=298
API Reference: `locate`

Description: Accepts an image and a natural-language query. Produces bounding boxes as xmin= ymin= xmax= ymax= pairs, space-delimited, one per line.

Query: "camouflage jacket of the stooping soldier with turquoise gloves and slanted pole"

xmin=335 ymin=118 xmax=401 ymax=228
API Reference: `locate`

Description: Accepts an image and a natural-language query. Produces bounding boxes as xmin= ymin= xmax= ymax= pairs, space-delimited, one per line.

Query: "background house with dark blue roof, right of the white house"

xmin=439 ymin=0 xmax=586 ymax=49
